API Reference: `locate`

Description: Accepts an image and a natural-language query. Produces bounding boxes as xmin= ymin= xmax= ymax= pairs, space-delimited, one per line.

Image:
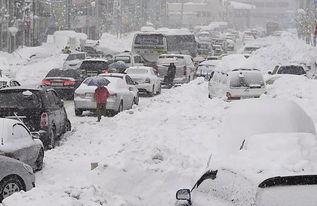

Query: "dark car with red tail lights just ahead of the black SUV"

xmin=42 ymin=69 xmax=82 ymax=100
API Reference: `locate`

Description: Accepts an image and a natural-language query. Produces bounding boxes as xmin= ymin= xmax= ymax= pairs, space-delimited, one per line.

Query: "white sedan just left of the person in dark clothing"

xmin=125 ymin=66 xmax=161 ymax=96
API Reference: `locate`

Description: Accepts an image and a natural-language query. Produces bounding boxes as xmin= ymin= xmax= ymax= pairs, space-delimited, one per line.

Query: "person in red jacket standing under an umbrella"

xmin=94 ymin=86 xmax=111 ymax=122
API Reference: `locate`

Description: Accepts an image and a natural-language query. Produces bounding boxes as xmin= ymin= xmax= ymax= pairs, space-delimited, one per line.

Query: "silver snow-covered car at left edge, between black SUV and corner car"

xmin=0 ymin=118 xmax=44 ymax=171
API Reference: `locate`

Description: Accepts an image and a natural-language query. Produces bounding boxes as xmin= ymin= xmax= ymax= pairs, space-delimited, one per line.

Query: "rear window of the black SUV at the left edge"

xmin=0 ymin=90 xmax=41 ymax=109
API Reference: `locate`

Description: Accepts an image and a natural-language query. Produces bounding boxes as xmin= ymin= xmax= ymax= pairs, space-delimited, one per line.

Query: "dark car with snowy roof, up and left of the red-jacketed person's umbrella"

xmin=79 ymin=59 xmax=109 ymax=79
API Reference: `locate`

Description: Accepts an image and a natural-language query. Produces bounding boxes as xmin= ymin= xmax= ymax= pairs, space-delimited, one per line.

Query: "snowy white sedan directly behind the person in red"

xmin=74 ymin=77 xmax=135 ymax=116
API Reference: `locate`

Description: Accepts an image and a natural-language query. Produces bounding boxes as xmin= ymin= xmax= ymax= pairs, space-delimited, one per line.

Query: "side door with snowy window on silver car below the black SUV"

xmin=9 ymin=123 xmax=40 ymax=165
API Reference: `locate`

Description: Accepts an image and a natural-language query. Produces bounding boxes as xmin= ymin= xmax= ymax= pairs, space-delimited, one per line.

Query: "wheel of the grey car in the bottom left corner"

xmin=0 ymin=176 xmax=24 ymax=202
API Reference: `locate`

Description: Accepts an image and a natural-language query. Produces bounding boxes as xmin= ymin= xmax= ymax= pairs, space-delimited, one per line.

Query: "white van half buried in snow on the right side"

xmin=208 ymin=69 xmax=266 ymax=100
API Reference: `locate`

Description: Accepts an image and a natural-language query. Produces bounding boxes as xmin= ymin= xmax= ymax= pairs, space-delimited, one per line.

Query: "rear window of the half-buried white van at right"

xmin=230 ymin=72 xmax=264 ymax=87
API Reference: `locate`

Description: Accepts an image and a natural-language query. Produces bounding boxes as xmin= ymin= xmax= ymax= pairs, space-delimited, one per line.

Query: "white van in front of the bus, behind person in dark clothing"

xmin=157 ymin=54 xmax=196 ymax=84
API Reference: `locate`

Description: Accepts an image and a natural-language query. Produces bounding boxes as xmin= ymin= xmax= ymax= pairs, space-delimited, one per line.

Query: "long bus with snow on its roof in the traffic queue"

xmin=132 ymin=29 xmax=197 ymax=62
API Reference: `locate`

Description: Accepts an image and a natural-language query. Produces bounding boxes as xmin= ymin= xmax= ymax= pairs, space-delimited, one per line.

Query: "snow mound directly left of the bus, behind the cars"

xmin=99 ymin=33 xmax=134 ymax=52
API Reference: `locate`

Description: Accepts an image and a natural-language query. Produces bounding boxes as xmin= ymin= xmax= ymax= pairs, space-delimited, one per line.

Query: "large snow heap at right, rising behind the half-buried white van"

xmin=245 ymin=33 xmax=317 ymax=72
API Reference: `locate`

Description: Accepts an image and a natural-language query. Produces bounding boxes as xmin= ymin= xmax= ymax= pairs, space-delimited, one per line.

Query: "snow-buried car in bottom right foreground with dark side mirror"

xmin=176 ymin=99 xmax=317 ymax=206
